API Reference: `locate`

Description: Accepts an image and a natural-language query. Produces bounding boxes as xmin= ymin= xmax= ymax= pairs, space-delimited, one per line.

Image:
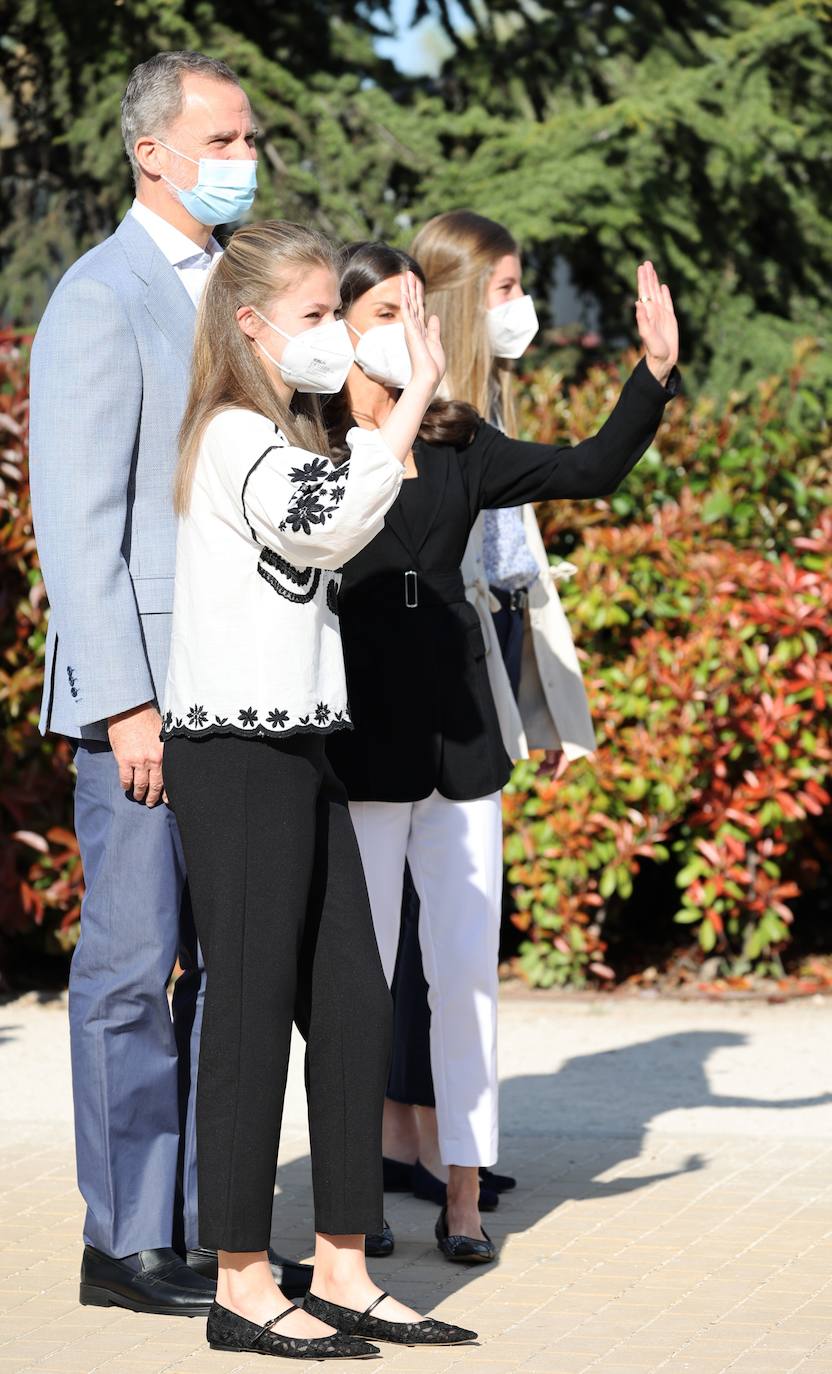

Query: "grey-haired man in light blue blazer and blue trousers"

xmin=30 ymin=52 xmax=311 ymax=1315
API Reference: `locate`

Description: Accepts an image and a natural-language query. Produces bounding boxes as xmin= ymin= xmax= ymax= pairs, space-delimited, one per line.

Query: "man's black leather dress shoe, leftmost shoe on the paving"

xmin=78 ymin=1245 xmax=216 ymax=1316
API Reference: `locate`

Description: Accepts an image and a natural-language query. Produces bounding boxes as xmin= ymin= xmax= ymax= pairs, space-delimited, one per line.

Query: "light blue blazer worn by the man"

xmin=30 ymin=214 xmax=195 ymax=739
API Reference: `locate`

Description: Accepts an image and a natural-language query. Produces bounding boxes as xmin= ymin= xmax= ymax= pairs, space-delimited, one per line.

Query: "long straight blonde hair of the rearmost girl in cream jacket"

xmin=411 ymin=210 xmax=518 ymax=436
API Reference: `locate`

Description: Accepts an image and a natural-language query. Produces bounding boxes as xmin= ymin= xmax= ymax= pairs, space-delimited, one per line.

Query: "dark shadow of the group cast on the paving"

xmin=267 ymin=1031 xmax=832 ymax=1311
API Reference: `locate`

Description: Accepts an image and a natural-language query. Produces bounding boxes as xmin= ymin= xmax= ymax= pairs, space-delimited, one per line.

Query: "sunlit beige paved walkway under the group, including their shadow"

xmin=0 ymin=995 xmax=832 ymax=1374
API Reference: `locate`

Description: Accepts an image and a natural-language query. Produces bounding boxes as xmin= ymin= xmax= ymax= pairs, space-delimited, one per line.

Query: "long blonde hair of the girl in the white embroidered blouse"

xmin=173 ymin=220 xmax=336 ymax=515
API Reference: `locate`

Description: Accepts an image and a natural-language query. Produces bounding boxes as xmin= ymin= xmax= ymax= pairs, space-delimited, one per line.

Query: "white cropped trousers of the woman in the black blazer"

xmin=350 ymin=791 xmax=502 ymax=1165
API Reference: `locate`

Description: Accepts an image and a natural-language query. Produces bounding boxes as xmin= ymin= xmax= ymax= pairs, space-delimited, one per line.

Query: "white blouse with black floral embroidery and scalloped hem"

xmin=162 ymin=409 xmax=404 ymax=739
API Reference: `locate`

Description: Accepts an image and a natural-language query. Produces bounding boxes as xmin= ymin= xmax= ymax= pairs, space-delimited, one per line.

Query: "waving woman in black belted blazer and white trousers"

xmin=327 ymin=245 xmax=678 ymax=1261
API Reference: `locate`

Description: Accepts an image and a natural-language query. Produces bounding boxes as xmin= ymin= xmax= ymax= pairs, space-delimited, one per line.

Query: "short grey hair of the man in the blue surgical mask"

xmin=121 ymin=52 xmax=240 ymax=185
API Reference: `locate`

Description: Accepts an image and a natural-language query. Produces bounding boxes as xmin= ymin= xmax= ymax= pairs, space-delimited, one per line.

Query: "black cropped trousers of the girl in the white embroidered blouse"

xmin=165 ymin=734 xmax=391 ymax=1250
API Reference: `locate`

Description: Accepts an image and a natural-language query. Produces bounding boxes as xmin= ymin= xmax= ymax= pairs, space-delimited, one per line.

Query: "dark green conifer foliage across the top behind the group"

xmin=0 ymin=0 xmax=832 ymax=400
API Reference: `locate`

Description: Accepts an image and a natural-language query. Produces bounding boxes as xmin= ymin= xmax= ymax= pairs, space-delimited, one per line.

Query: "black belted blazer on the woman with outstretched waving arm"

xmin=327 ymin=361 xmax=680 ymax=801
